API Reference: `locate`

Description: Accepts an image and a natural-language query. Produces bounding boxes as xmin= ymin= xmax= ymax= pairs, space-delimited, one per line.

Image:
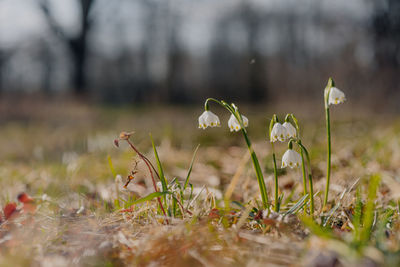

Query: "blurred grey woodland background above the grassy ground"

xmin=0 ymin=0 xmax=400 ymax=112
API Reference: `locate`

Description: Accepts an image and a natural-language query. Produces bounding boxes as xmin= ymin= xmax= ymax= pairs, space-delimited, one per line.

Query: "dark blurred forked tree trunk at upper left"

xmin=39 ymin=0 xmax=95 ymax=95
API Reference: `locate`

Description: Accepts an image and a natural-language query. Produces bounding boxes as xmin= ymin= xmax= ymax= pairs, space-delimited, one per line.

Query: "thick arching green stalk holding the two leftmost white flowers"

xmin=204 ymin=98 xmax=268 ymax=208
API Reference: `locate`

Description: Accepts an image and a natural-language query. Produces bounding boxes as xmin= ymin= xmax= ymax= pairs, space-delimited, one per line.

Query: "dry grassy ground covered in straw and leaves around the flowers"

xmin=0 ymin=101 xmax=400 ymax=266
